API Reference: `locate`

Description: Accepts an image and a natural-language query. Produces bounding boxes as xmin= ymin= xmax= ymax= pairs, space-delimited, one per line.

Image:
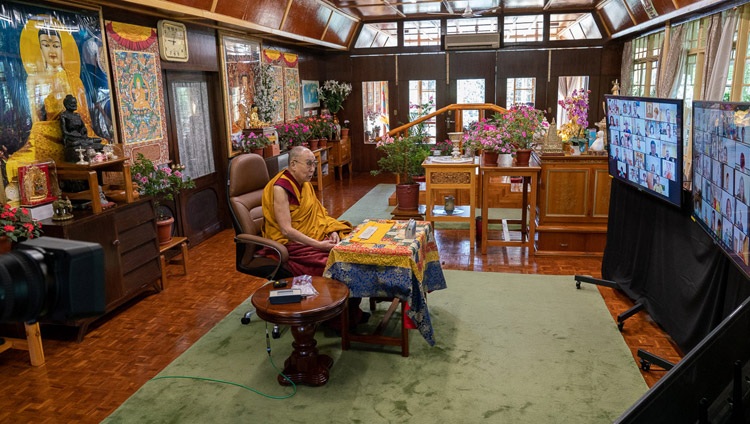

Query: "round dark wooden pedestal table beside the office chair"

xmin=252 ymin=277 xmax=349 ymax=386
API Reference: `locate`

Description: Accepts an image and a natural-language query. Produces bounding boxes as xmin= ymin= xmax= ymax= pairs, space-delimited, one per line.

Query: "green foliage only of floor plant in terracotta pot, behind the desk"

xmin=371 ymin=135 xmax=429 ymax=184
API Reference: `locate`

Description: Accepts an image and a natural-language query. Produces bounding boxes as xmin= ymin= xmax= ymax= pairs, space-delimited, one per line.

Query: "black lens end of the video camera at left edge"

xmin=0 ymin=250 xmax=47 ymax=322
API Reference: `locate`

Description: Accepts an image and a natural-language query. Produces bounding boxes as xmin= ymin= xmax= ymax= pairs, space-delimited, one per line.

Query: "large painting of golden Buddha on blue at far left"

xmin=0 ymin=2 xmax=117 ymax=183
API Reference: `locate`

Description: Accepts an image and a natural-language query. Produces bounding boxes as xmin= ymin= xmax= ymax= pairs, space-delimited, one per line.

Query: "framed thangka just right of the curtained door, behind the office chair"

xmin=221 ymin=34 xmax=260 ymax=156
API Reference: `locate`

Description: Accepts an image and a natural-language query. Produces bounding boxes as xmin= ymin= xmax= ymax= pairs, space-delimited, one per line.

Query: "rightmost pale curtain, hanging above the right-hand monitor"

xmin=703 ymin=10 xmax=739 ymax=100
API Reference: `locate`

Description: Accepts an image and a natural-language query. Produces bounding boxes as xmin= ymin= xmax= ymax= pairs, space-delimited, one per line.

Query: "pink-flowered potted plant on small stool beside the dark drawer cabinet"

xmin=130 ymin=153 xmax=195 ymax=244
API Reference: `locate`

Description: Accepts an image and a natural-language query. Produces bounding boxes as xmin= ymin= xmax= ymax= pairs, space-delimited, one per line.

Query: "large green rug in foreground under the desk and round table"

xmin=105 ymin=271 xmax=647 ymax=424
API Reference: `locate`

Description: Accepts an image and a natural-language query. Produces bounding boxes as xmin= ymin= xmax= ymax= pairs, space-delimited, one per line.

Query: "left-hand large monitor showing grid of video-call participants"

xmin=605 ymin=95 xmax=683 ymax=207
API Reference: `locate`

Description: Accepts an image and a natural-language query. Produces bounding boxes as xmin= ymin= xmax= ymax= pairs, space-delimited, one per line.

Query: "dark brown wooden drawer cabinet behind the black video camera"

xmin=42 ymin=199 xmax=161 ymax=340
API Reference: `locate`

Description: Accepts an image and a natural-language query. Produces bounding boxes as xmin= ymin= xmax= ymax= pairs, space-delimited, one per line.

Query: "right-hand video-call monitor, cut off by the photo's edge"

xmin=692 ymin=102 xmax=750 ymax=275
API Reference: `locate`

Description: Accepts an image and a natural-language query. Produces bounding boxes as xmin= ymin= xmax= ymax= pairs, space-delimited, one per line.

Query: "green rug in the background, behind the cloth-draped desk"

xmin=339 ymin=184 xmax=521 ymax=230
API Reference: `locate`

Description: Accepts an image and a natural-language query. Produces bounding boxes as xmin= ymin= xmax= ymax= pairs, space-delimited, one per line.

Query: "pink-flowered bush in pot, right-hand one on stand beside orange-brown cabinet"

xmin=502 ymin=105 xmax=549 ymax=166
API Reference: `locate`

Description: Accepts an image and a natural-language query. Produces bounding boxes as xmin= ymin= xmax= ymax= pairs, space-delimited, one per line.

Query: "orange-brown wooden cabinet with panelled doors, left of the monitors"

xmin=536 ymin=155 xmax=610 ymax=256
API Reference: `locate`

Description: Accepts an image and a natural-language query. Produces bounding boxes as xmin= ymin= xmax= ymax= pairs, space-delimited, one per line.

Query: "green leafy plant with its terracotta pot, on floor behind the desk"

xmin=372 ymin=135 xmax=429 ymax=210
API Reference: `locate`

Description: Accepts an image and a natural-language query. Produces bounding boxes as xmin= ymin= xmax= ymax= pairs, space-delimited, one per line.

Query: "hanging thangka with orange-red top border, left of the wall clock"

xmin=106 ymin=21 xmax=169 ymax=163
